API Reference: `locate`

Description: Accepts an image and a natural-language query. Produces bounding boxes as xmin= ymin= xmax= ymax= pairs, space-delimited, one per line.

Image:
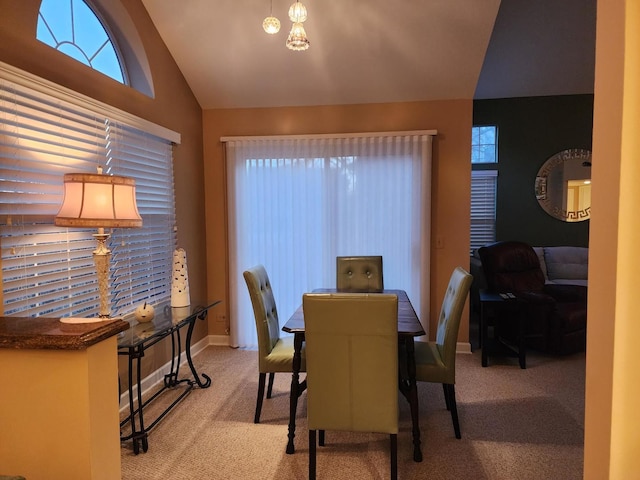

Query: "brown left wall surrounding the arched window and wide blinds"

xmin=0 ymin=0 xmax=207 ymax=376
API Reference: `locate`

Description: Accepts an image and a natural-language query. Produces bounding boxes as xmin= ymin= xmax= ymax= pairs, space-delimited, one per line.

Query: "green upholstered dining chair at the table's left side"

xmin=243 ymin=265 xmax=305 ymax=423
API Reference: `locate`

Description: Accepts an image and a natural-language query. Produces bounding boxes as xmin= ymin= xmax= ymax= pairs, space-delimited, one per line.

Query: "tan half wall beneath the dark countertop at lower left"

xmin=0 ymin=336 xmax=120 ymax=480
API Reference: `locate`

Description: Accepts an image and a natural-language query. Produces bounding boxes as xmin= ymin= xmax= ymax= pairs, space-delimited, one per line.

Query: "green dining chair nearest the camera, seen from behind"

xmin=302 ymin=293 xmax=398 ymax=479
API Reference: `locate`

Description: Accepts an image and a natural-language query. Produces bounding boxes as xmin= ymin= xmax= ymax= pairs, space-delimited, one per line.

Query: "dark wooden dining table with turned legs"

xmin=282 ymin=288 xmax=425 ymax=462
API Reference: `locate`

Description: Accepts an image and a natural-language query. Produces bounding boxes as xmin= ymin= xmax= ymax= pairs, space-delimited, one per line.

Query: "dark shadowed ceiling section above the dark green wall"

xmin=475 ymin=0 xmax=597 ymax=98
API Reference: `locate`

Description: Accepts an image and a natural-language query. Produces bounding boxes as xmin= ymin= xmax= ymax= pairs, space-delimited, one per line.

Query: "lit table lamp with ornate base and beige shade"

xmin=54 ymin=168 xmax=142 ymax=319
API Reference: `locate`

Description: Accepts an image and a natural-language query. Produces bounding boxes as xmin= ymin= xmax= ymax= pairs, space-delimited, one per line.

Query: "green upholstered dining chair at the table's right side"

xmin=414 ymin=267 xmax=473 ymax=438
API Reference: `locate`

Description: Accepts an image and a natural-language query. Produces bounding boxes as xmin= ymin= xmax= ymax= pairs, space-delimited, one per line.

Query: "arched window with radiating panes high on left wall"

xmin=36 ymin=0 xmax=127 ymax=83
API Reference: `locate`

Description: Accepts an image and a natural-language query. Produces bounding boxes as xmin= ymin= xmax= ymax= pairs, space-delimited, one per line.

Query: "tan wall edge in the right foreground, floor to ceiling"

xmin=584 ymin=0 xmax=640 ymax=480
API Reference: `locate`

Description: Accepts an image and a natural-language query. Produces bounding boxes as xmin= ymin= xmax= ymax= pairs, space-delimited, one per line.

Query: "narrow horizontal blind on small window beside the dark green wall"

xmin=470 ymin=170 xmax=498 ymax=252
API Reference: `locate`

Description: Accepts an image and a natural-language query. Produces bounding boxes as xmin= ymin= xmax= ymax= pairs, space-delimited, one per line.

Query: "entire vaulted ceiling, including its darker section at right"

xmin=143 ymin=0 xmax=596 ymax=109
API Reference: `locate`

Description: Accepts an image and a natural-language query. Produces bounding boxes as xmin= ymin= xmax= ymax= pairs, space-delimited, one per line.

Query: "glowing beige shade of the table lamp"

xmin=55 ymin=173 xmax=142 ymax=228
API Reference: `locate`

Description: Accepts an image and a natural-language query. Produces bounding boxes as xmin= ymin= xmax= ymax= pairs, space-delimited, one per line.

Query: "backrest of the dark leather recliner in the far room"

xmin=478 ymin=240 xmax=544 ymax=292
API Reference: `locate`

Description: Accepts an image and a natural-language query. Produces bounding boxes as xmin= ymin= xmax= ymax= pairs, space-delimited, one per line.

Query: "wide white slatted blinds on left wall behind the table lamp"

xmin=0 ymin=65 xmax=176 ymax=316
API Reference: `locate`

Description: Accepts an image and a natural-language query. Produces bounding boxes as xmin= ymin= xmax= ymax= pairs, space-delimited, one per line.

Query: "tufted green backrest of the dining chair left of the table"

xmin=243 ymin=265 xmax=280 ymax=372
